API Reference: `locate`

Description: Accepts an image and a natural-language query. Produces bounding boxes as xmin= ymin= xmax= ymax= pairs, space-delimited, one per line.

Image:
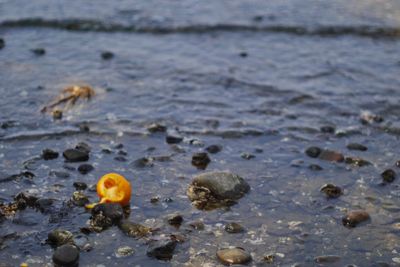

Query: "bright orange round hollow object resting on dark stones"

xmin=93 ymin=173 xmax=131 ymax=206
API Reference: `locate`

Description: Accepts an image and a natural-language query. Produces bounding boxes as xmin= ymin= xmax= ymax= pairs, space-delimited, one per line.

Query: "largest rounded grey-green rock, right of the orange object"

xmin=187 ymin=172 xmax=250 ymax=209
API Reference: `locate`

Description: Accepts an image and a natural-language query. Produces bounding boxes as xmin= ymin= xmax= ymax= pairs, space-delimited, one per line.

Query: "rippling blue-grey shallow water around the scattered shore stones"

xmin=0 ymin=0 xmax=400 ymax=266
